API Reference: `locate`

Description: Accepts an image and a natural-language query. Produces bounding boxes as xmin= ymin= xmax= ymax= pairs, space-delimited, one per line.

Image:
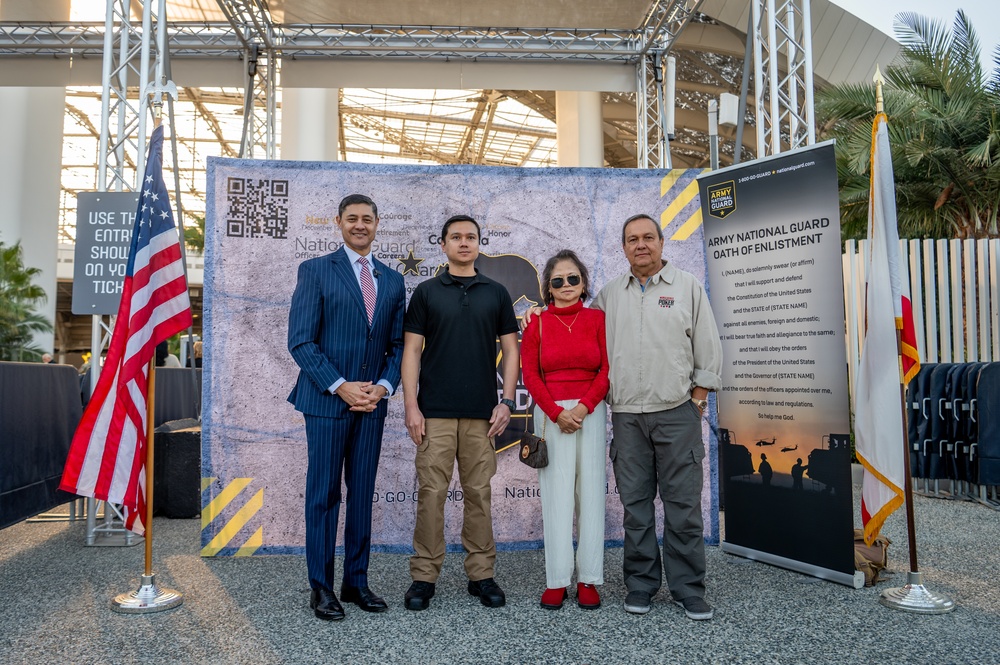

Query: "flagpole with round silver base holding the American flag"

xmin=111 ymin=105 xmax=184 ymax=614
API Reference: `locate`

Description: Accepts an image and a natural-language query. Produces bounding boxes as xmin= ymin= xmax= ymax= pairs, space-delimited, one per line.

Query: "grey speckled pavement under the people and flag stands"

xmin=0 ymin=488 xmax=1000 ymax=664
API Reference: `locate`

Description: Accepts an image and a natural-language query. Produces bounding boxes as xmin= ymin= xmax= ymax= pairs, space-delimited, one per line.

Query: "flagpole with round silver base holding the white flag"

xmin=872 ymin=65 xmax=955 ymax=614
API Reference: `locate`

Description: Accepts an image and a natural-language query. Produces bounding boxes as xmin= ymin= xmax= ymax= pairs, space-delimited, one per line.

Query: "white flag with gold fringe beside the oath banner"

xmin=854 ymin=113 xmax=920 ymax=544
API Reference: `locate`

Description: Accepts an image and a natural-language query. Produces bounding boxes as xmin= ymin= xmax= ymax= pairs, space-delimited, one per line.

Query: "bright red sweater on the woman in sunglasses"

xmin=521 ymin=301 xmax=610 ymax=422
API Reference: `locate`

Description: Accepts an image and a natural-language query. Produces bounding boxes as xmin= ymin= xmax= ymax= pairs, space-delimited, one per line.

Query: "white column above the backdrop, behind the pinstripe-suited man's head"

xmin=281 ymin=88 xmax=340 ymax=161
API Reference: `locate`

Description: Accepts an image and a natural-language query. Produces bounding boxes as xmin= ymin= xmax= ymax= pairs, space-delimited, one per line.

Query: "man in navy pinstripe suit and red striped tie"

xmin=288 ymin=194 xmax=406 ymax=621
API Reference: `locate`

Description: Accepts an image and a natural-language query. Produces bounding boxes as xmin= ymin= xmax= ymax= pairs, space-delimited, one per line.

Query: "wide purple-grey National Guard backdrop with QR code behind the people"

xmin=202 ymin=159 xmax=719 ymax=556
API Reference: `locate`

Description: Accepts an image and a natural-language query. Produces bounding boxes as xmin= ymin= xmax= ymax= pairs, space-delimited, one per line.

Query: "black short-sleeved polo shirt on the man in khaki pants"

xmin=403 ymin=270 xmax=517 ymax=419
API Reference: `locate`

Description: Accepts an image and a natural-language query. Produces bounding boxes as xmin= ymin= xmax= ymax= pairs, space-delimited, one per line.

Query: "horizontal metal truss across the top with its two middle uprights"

xmin=0 ymin=0 xmax=736 ymax=167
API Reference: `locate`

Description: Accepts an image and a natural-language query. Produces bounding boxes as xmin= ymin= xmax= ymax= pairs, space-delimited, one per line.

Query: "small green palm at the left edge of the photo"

xmin=0 ymin=243 xmax=52 ymax=360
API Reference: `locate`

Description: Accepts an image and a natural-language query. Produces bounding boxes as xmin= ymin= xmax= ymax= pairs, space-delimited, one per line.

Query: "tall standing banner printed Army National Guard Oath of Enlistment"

xmin=699 ymin=142 xmax=863 ymax=586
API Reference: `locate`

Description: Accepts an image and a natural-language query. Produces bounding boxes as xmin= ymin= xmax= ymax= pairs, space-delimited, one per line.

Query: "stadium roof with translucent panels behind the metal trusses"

xmin=0 ymin=0 xmax=899 ymax=352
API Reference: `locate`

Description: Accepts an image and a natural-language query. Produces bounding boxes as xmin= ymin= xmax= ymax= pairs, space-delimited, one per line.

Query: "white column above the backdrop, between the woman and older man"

xmin=556 ymin=91 xmax=604 ymax=167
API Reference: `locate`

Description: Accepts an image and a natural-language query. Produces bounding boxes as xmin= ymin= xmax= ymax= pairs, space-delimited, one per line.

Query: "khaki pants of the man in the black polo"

xmin=410 ymin=418 xmax=497 ymax=582
